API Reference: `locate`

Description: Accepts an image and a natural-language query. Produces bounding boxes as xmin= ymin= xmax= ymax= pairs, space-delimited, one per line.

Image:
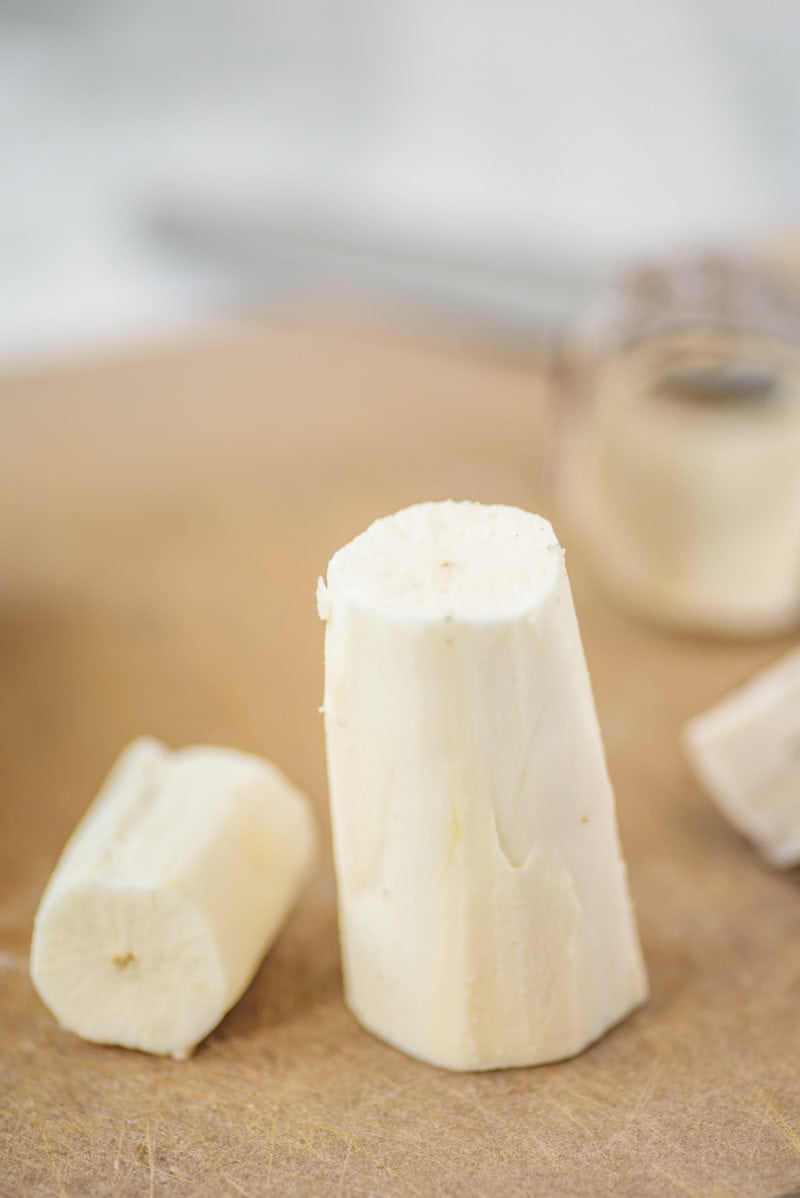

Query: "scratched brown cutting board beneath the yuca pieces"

xmin=0 ymin=320 xmax=800 ymax=1198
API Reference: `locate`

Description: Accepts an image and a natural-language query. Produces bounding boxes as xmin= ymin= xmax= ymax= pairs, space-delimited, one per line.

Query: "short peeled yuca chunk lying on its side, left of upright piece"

xmin=31 ymin=738 xmax=316 ymax=1058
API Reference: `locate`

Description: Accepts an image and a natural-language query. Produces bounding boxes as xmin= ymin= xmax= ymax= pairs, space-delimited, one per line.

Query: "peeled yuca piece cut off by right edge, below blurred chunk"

xmin=684 ymin=649 xmax=800 ymax=869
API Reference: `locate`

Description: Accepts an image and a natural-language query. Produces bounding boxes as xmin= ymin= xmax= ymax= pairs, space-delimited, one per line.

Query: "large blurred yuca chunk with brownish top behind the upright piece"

xmin=560 ymin=260 xmax=800 ymax=635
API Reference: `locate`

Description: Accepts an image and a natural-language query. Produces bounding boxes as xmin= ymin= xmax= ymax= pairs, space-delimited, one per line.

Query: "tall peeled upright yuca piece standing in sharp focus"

xmin=319 ymin=502 xmax=647 ymax=1070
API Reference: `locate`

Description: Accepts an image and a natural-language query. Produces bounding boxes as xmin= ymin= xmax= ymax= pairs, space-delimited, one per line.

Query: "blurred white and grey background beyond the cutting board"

xmin=0 ymin=0 xmax=800 ymax=363
